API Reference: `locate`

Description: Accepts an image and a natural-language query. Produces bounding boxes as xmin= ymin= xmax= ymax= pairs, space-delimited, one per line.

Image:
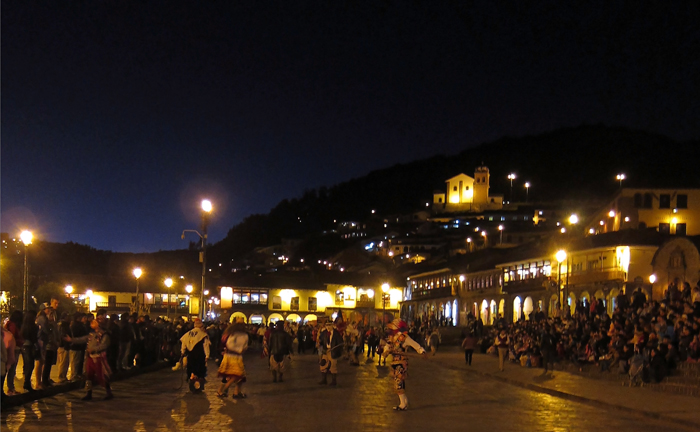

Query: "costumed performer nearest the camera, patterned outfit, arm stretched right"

xmin=382 ymin=319 xmax=427 ymax=411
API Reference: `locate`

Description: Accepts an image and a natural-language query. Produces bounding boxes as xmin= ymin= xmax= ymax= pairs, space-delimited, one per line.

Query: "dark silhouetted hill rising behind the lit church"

xmin=211 ymin=125 xmax=700 ymax=257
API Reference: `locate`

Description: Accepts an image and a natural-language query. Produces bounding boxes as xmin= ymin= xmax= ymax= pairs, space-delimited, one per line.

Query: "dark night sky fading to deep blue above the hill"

xmin=1 ymin=0 xmax=700 ymax=252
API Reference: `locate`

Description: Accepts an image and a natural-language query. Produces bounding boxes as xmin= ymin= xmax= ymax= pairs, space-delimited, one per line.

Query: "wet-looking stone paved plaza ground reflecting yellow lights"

xmin=0 ymin=350 xmax=697 ymax=432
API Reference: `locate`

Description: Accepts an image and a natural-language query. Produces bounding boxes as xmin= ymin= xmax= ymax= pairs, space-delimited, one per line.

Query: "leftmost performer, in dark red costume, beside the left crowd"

xmin=64 ymin=320 xmax=114 ymax=401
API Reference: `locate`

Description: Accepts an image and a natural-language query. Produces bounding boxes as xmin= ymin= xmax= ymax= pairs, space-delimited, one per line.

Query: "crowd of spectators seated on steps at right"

xmin=476 ymin=282 xmax=700 ymax=385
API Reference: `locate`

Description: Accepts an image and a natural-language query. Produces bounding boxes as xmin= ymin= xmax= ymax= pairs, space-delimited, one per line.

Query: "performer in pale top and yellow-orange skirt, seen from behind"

xmin=216 ymin=321 xmax=248 ymax=399
